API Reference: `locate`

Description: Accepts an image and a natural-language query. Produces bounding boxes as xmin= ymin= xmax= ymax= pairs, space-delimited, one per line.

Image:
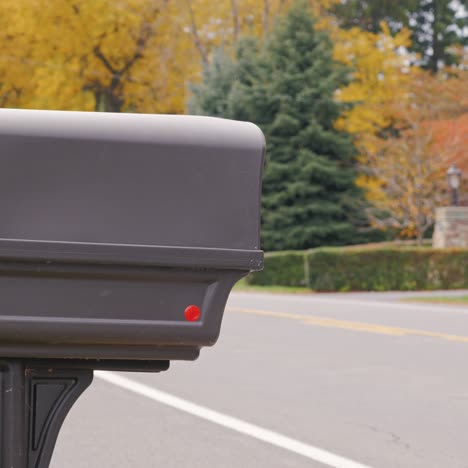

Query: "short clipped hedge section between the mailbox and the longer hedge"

xmin=246 ymin=251 xmax=307 ymax=286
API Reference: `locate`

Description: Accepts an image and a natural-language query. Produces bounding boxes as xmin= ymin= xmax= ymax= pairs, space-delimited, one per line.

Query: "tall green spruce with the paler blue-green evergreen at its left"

xmin=190 ymin=2 xmax=370 ymax=251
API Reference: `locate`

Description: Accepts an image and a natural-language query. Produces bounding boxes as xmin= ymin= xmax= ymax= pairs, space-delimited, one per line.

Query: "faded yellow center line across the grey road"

xmin=227 ymin=307 xmax=468 ymax=343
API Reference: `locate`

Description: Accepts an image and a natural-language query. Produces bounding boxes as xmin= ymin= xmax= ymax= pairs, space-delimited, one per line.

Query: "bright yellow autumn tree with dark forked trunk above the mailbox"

xmin=0 ymin=0 xmax=192 ymax=112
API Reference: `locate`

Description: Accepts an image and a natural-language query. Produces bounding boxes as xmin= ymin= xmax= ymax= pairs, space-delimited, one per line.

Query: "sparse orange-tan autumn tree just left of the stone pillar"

xmin=362 ymin=71 xmax=468 ymax=243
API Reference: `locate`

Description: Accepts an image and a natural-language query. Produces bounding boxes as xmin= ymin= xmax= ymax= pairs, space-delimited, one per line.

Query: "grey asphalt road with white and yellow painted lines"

xmin=51 ymin=293 xmax=468 ymax=468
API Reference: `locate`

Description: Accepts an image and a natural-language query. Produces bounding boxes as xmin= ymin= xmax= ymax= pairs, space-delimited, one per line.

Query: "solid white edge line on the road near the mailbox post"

xmin=95 ymin=371 xmax=369 ymax=468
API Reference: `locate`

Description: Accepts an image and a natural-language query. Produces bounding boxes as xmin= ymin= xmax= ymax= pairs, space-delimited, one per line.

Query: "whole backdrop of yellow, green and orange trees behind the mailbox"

xmin=0 ymin=0 xmax=468 ymax=250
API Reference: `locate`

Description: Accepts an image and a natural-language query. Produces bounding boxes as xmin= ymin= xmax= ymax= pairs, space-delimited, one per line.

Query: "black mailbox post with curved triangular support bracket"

xmin=0 ymin=360 xmax=93 ymax=468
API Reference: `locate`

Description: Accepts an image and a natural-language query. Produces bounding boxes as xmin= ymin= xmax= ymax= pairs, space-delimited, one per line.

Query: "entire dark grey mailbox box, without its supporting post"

xmin=0 ymin=109 xmax=264 ymax=360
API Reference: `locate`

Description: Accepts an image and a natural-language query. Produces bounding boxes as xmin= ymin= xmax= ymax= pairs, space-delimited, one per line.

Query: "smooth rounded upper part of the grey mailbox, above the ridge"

xmin=0 ymin=109 xmax=265 ymax=251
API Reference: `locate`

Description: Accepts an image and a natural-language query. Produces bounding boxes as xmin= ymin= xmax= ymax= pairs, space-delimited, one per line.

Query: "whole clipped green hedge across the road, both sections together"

xmin=247 ymin=245 xmax=468 ymax=291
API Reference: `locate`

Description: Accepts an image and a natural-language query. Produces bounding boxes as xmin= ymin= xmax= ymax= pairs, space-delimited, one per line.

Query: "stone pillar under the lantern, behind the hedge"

xmin=432 ymin=206 xmax=468 ymax=248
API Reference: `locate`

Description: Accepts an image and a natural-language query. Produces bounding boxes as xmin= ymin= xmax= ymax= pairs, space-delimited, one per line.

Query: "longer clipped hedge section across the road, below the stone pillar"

xmin=306 ymin=247 xmax=468 ymax=291
